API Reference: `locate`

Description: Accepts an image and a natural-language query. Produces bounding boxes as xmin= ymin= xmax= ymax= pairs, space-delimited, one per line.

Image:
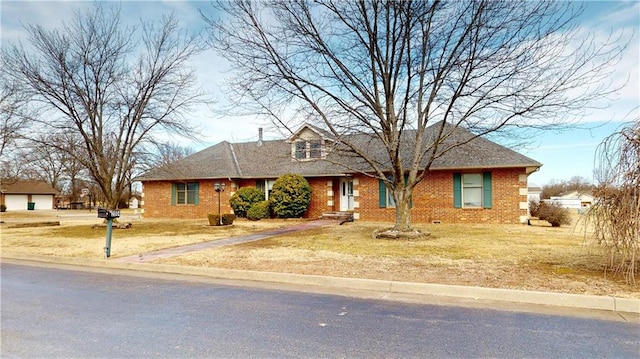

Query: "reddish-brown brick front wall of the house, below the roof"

xmin=142 ymin=168 xmax=527 ymax=223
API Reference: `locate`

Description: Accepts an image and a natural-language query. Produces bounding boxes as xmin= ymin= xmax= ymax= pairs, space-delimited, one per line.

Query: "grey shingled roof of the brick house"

xmin=137 ymin=124 xmax=541 ymax=181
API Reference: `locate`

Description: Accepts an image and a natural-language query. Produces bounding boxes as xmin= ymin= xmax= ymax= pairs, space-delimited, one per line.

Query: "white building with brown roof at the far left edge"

xmin=0 ymin=180 xmax=57 ymax=211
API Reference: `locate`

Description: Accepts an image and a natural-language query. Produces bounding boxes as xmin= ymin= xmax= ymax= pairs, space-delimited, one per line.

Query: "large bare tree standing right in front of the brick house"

xmin=201 ymin=0 xmax=625 ymax=231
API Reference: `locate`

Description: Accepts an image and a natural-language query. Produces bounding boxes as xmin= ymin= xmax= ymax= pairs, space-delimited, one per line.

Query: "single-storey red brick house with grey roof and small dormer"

xmin=137 ymin=125 xmax=541 ymax=223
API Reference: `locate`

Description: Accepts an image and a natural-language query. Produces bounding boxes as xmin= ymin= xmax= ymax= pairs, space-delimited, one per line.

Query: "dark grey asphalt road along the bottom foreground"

xmin=0 ymin=263 xmax=640 ymax=358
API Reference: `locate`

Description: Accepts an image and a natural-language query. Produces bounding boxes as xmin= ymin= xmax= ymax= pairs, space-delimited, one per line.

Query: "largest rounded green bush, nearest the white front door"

xmin=269 ymin=174 xmax=311 ymax=218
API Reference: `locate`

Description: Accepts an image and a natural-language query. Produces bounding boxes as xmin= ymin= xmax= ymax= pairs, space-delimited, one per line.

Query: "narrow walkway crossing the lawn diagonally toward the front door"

xmin=115 ymin=220 xmax=336 ymax=263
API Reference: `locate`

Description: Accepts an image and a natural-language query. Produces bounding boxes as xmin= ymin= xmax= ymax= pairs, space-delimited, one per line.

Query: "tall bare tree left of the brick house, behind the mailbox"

xmin=1 ymin=3 xmax=202 ymax=208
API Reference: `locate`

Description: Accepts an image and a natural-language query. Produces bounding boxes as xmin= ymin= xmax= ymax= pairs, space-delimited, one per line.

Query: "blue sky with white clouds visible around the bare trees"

xmin=0 ymin=0 xmax=640 ymax=185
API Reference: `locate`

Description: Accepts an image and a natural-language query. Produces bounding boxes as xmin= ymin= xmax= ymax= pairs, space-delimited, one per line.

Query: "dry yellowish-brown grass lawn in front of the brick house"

xmin=1 ymin=208 xmax=640 ymax=298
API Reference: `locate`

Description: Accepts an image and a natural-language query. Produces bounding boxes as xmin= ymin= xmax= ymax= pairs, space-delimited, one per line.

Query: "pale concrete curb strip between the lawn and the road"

xmin=2 ymin=255 xmax=640 ymax=314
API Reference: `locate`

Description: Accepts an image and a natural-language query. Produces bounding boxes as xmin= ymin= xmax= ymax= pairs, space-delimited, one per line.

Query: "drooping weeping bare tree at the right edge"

xmin=588 ymin=119 xmax=640 ymax=284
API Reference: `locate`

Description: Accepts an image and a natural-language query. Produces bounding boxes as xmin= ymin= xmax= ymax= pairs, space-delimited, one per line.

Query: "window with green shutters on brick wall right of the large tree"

xmin=453 ymin=172 xmax=492 ymax=208
